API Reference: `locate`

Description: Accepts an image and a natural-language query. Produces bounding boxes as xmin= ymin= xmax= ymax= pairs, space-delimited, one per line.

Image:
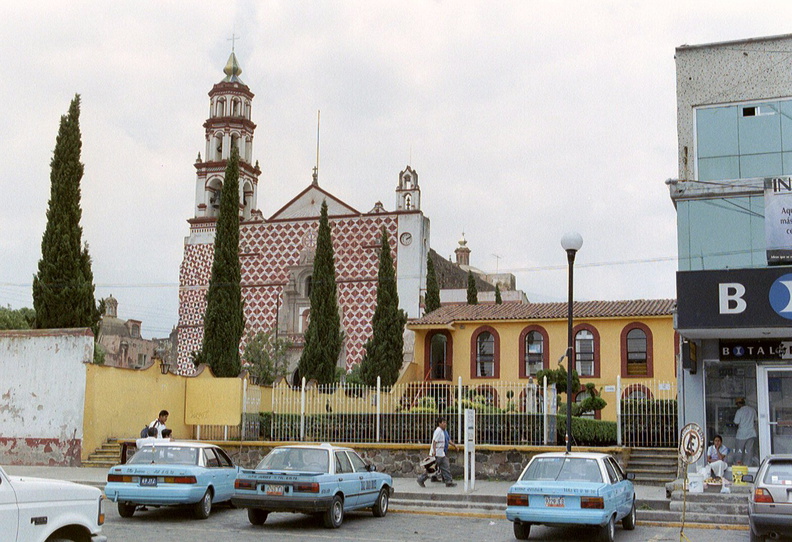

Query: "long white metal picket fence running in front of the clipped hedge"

xmin=271 ymin=379 xmax=556 ymax=445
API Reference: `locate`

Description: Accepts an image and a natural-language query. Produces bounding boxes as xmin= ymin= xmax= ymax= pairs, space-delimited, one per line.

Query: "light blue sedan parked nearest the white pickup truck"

xmin=105 ymin=440 xmax=239 ymax=519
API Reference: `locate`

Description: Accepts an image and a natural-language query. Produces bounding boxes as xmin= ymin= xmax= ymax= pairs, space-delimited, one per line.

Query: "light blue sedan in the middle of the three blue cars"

xmin=231 ymin=444 xmax=393 ymax=528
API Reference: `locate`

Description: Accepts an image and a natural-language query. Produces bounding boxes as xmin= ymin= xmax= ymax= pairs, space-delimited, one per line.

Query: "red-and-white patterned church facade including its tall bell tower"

xmin=177 ymin=52 xmax=429 ymax=373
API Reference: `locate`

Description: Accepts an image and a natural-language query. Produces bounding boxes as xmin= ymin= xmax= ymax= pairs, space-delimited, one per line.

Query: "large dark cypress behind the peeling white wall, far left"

xmin=33 ymin=94 xmax=102 ymax=336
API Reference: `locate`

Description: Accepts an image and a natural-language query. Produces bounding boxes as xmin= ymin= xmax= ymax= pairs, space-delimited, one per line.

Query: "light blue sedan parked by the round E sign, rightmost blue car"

xmin=506 ymin=452 xmax=635 ymax=542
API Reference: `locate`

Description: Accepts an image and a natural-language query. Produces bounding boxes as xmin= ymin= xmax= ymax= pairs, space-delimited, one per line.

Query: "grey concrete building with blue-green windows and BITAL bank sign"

xmin=667 ymin=35 xmax=792 ymax=465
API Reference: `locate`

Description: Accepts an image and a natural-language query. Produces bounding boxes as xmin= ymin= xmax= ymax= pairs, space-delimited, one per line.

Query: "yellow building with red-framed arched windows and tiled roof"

xmin=407 ymin=299 xmax=677 ymax=420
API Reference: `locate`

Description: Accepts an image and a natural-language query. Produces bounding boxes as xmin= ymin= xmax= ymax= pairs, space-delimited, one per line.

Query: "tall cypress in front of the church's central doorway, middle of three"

xmin=297 ymin=201 xmax=344 ymax=384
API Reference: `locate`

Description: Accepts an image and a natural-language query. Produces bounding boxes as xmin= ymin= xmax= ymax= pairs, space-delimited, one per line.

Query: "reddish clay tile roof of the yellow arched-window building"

xmin=408 ymin=299 xmax=676 ymax=326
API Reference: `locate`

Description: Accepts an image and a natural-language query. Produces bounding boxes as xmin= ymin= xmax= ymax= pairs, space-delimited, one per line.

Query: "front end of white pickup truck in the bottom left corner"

xmin=0 ymin=467 xmax=107 ymax=542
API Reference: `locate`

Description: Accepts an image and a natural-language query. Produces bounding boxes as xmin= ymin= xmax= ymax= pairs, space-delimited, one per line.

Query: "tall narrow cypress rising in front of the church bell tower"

xmin=198 ymin=147 xmax=245 ymax=377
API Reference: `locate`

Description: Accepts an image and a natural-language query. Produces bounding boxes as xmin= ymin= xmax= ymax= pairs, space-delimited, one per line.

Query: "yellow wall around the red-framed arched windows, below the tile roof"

xmin=413 ymin=315 xmax=676 ymax=420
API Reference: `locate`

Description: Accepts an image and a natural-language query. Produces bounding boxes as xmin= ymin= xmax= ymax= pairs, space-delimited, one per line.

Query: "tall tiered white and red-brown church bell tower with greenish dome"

xmin=195 ymin=50 xmax=261 ymax=221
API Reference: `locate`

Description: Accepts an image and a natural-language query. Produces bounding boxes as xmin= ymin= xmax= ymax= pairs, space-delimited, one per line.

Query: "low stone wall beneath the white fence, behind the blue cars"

xmin=217 ymin=442 xmax=627 ymax=481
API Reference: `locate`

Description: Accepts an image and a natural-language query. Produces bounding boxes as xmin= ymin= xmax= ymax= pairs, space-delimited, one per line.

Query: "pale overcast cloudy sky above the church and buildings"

xmin=0 ymin=0 xmax=792 ymax=337
